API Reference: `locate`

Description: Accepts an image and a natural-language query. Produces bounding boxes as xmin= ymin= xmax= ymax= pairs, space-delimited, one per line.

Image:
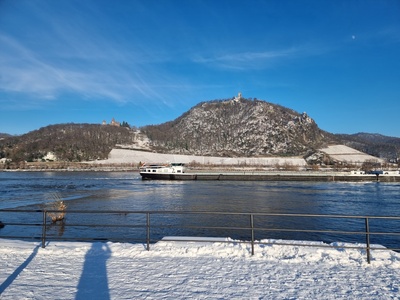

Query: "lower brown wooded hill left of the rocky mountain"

xmin=0 ymin=123 xmax=135 ymax=163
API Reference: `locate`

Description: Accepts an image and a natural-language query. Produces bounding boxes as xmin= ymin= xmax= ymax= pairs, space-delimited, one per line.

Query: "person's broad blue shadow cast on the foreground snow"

xmin=75 ymin=243 xmax=111 ymax=300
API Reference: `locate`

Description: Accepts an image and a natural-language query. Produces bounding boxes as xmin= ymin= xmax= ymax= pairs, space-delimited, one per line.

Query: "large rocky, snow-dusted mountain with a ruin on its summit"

xmin=142 ymin=94 xmax=333 ymax=156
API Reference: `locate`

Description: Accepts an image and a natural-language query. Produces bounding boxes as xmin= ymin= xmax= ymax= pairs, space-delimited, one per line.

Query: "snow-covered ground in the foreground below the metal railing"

xmin=0 ymin=238 xmax=400 ymax=300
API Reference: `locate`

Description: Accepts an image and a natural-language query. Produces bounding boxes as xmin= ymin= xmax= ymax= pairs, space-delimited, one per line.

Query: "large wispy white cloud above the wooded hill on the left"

xmin=0 ymin=35 xmax=169 ymax=102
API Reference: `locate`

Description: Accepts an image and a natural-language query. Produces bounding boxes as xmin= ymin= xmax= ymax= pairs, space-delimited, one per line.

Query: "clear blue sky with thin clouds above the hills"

xmin=0 ymin=0 xmax=400 ymax=137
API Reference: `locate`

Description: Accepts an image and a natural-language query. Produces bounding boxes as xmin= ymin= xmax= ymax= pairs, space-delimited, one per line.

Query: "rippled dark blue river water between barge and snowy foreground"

xmin=0 ymin=172 xmax=400 ymax=248
